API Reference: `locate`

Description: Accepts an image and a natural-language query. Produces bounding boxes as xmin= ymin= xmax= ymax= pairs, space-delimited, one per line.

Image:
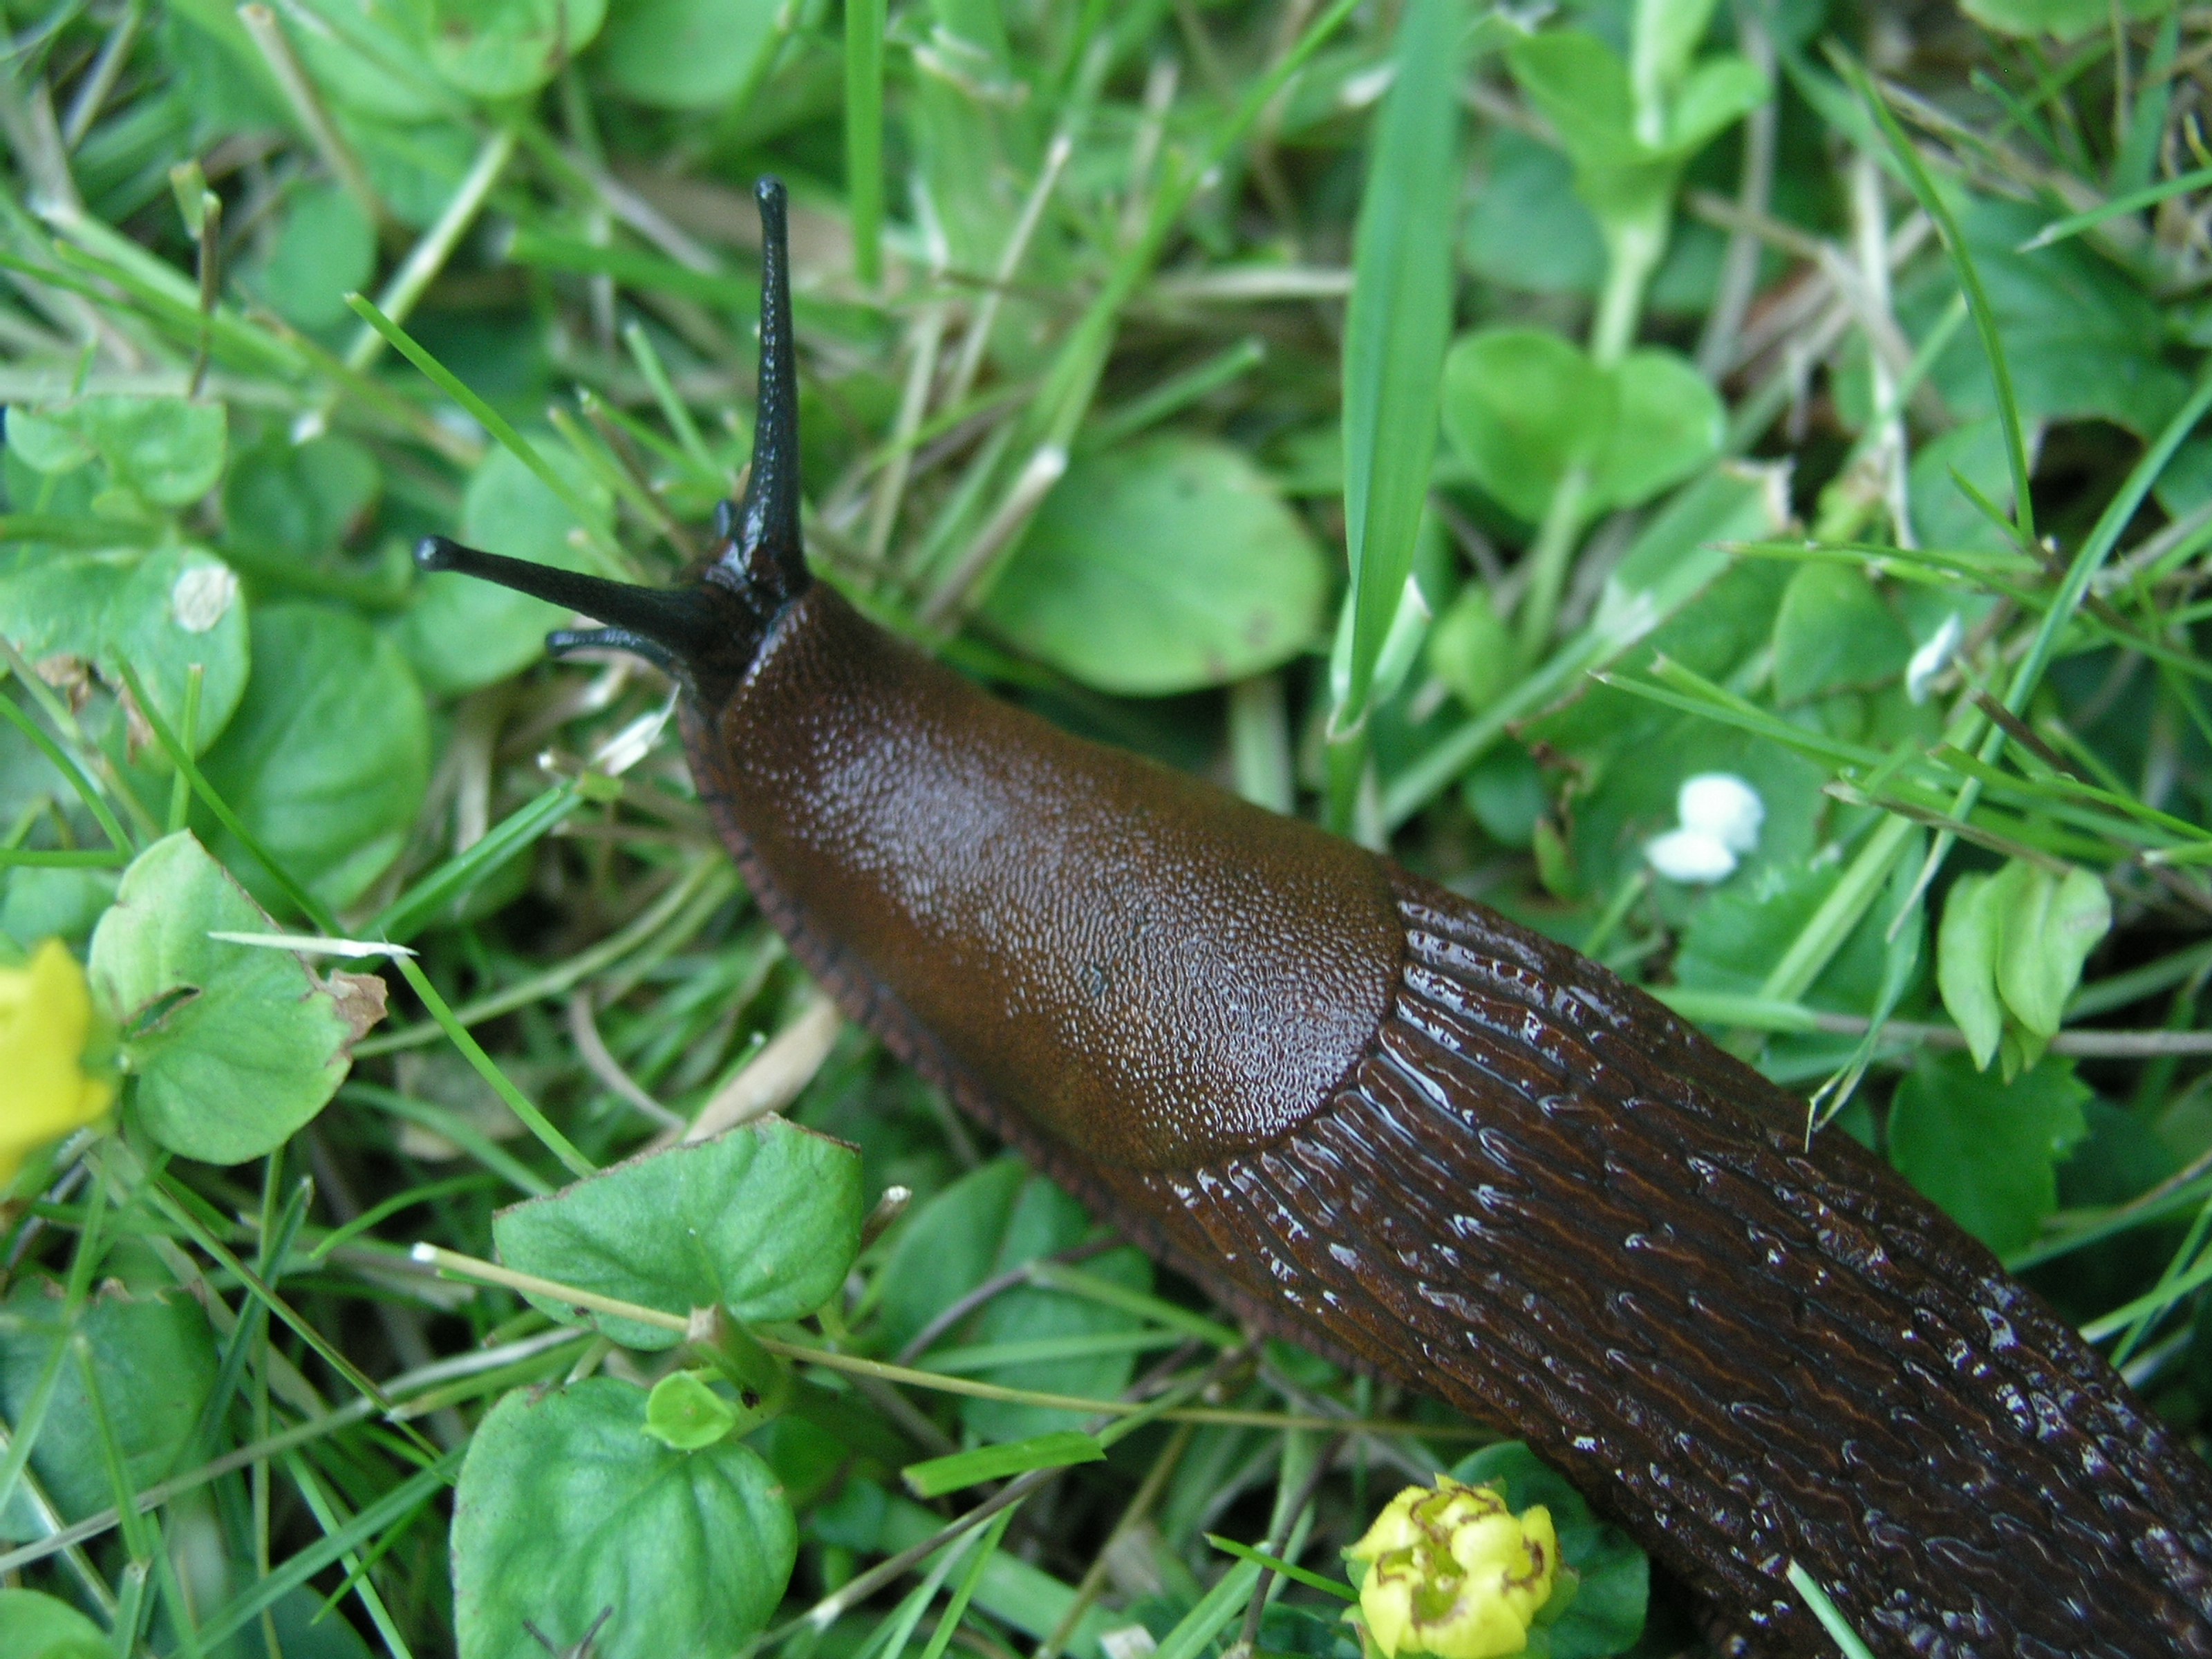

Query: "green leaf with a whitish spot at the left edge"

xmin=0 ymin=546 xmax=247 ymax=754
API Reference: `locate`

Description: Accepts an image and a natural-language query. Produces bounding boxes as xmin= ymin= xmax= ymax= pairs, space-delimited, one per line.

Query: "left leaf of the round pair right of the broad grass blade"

xmin=1445 ymin=328 xmax=1615 ymax=522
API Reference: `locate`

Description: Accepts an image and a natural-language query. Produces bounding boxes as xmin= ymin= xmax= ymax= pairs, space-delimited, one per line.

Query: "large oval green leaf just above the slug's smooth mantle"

xmin=984 ymin=433 xmax=1327 ymax=697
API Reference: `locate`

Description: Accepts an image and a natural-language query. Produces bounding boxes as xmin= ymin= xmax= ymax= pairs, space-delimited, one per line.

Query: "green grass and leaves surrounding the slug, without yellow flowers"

xmin=0 ymin=0 xmax=2212 ymax=1659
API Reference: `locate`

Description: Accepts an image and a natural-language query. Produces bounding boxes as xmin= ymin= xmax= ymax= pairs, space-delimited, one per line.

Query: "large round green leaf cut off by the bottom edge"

xmin=453 ymin=1378 xmax=798 ymax=1659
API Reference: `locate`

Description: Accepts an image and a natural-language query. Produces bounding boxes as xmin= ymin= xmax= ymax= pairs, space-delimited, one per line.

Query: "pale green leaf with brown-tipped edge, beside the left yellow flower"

xmin=91 ymin=830 xmax=350 ymax=1163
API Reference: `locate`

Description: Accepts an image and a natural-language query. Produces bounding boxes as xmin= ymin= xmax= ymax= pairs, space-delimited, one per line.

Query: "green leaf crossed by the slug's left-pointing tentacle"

xmin=398 ymin=442 xmax=612 ymax=697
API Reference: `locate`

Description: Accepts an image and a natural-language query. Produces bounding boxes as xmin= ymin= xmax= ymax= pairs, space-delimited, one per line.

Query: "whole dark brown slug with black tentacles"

xmin=418 ymin=181 xmax=2212 ymax=1659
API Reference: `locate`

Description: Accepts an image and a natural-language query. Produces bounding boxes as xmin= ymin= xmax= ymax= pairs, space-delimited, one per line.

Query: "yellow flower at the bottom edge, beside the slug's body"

xmin=1345 ymin=1475 xmax=1559 ymax=1659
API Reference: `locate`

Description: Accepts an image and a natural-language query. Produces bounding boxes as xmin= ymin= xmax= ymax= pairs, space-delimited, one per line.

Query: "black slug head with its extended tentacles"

xmin=416 ymin=179 xmax=809 ymax=706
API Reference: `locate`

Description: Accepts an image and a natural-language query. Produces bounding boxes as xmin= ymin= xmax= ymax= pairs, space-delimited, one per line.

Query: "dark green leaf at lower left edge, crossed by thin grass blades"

xmin=0 ymin=1276 xmax=214 ymax=1539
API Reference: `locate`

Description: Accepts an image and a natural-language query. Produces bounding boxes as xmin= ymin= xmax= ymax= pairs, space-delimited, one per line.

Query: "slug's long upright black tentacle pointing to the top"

xmin=708 ymin=179 xmax=807 ymax=604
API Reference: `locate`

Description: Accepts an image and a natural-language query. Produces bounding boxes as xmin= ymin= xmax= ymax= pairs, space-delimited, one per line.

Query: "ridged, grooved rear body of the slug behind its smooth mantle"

xmin=1117 ymin=876 xmax=2212 ymax=1659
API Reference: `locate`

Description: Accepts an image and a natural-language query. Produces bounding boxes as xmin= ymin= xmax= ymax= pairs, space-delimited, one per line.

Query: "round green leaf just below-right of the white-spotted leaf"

xmin=206 ymin=604 xmax=429 ymax=907
